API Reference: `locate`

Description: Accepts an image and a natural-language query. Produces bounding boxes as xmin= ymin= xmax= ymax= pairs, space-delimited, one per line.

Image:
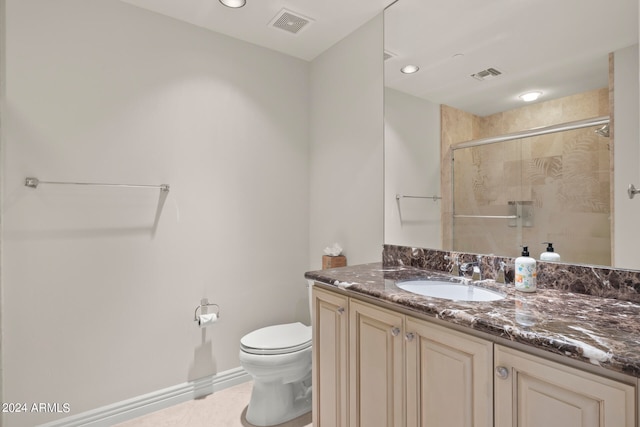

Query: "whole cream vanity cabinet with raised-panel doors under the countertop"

xmin=313 ymin=286 xmax=637 ymax=427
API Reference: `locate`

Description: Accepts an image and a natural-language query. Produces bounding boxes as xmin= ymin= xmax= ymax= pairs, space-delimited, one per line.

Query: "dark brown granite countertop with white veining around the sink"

xmin=305 ymin=263 xmax=640 ymax=377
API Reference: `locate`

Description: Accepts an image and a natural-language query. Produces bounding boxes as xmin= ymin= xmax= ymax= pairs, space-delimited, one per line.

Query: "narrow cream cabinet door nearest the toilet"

xmin=312 ymin=287 xmax=349 ymax=427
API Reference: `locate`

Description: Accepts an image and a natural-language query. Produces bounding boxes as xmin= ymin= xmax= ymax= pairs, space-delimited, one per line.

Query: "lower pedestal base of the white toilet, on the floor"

xmin=246 ymin=374 xmax=311 ymax=427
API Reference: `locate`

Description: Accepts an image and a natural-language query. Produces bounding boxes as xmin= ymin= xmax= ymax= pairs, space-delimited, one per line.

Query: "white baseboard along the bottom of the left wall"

xmin=39 ymin=368 xmax=251 ymax=427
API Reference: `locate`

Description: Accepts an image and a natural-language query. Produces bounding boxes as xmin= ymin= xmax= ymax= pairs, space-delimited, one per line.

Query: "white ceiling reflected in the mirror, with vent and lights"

xmin=385 ymin=0 xmax=638 ymax=116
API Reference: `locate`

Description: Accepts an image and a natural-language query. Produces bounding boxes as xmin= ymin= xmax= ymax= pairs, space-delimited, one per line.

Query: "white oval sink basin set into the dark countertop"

xmin=396 ymin=279 xmax=506 ymax=301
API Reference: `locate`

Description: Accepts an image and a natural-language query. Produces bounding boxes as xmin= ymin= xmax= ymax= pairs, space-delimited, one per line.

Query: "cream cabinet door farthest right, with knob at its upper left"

xmin=495 ymin=345 xmax=636 ymax=427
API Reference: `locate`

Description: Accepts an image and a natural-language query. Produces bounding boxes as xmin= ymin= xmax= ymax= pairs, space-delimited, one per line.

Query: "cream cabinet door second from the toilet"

xmin=349 ymin=300 xmax=405 ymax=427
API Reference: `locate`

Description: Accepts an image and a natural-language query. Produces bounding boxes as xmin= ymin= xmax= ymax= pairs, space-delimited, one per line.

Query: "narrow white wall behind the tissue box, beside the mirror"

xmin=309 ymin=14 xmax=384 ymax=269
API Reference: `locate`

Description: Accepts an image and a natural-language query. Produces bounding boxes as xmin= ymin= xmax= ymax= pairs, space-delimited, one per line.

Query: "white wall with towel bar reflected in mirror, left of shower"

xmin=384 ymin=89 xmax=442 ymax=248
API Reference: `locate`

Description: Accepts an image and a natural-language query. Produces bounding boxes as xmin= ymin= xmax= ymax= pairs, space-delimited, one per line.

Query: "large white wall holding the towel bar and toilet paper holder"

xmin=2 ymin=0 xmax=310 ymax=427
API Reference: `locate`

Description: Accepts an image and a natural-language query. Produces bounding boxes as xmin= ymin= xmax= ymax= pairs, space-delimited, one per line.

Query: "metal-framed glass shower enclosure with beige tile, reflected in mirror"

xmin=451 ymin=117 xmax=611 ymax=265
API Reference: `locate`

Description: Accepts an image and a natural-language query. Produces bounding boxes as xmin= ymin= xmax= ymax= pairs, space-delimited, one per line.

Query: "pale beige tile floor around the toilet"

xmin=114 ymin=382 xmax=312 ymax=427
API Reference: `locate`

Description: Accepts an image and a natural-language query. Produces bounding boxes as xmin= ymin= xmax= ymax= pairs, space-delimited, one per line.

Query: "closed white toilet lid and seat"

xmin=240 ymin=322 xmax=311 ymax=354
